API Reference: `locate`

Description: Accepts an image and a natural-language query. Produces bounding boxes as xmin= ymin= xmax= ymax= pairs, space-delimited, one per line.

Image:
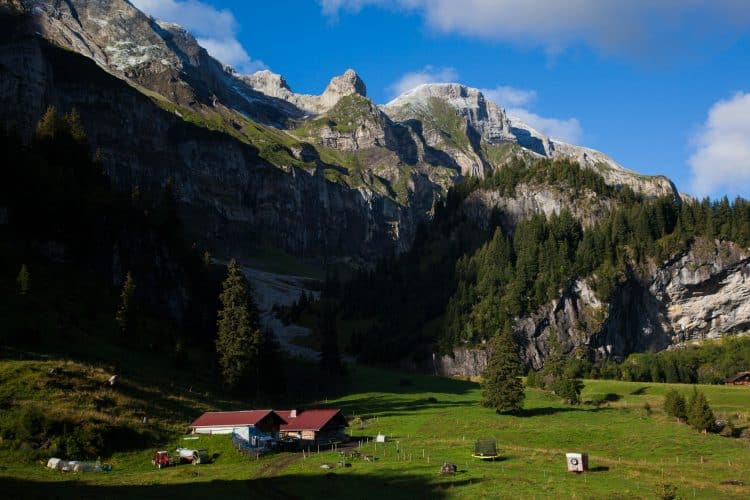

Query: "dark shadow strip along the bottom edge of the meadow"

xmin=0 ymin=466 xmax=480 ymax=500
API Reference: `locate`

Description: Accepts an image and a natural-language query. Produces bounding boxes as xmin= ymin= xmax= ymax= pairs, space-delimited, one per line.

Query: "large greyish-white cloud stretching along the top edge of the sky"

xmin=319 ymin=0 xmax=750 ymax=58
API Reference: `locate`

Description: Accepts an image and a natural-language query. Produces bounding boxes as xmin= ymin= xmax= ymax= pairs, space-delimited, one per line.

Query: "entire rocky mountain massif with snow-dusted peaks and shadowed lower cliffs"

xmin=0 ymin=0 xmax=688 ymax=268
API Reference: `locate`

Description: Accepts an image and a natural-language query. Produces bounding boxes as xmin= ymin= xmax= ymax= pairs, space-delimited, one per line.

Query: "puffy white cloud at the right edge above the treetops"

xmin=688 ymin=92 xmax=750 ymax=197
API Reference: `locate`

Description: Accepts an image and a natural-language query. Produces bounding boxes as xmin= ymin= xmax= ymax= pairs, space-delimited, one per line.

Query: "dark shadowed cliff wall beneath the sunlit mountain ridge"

xmin=0 ymin=27 xmax=424 ymax=261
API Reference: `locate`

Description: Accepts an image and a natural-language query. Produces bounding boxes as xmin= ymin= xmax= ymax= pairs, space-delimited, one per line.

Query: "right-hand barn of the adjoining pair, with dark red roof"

xmin=276 ymin=409 xmax=349 ymax=443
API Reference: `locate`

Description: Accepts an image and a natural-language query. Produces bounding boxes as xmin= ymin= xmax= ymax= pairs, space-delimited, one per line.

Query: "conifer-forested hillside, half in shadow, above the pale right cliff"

xmin=328 ymin=160 xmax=750 ymax=370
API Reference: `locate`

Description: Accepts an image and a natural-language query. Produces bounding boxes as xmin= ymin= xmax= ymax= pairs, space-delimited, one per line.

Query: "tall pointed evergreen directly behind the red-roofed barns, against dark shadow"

xmin=216 ymin=259 xmax=263 ymax=393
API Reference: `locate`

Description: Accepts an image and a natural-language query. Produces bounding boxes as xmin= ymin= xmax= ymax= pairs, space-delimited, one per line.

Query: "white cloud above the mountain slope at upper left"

xmin=131 ymin=0 xmax=266 ymax=73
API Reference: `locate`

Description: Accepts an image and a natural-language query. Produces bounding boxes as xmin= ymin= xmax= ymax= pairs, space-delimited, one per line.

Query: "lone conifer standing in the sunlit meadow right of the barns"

xmin=482 ymin=328 xmax=525 ymax=413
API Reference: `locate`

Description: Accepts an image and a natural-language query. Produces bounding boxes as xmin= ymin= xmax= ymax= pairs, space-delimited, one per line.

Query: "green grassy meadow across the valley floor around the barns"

xmin=0 ymin=368 xmax=750 ymax=498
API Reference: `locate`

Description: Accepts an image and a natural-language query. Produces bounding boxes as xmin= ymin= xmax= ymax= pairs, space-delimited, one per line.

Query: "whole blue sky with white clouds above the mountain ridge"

xmin=132 ymin=0 xmax=750 ymax=198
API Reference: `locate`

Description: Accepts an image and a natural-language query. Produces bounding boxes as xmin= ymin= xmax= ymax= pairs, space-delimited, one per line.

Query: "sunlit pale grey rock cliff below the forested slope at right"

xmin=435 ymin=239 xmax=750 ymax=376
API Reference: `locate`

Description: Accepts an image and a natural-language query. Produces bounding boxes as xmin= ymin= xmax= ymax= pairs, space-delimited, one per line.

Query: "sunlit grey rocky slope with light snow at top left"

xmin=16 ymin=0 xmax=302 ymax=124
